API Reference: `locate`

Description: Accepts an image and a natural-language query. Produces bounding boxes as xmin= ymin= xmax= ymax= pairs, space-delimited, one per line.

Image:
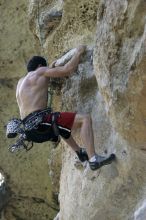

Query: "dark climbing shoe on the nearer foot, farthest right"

xmin=89 ymin=154 xmax=116 ymax=170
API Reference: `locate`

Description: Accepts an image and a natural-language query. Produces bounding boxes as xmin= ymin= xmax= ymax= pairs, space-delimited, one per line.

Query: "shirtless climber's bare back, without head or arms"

xmin=16 ymin=70 xmax=49 ymax=119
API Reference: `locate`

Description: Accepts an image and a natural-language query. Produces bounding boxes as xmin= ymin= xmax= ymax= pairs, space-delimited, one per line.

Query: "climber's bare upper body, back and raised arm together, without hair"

xmin=16 ymin=45 xmax=86 ymax=119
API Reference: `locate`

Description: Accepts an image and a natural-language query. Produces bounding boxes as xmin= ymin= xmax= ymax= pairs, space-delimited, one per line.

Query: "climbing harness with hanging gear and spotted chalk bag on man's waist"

xmin=6 ymin=107 xmax=60 ymax=153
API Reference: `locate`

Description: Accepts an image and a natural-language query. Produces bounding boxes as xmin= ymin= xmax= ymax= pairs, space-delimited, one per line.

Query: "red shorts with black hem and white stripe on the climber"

xmin=43 ymin=112 xmax=76 ymax=139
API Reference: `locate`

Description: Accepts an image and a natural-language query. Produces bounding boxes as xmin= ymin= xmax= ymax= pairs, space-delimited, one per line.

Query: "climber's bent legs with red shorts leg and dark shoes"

xmin=58 ymin=113 xmax=115 ymax=170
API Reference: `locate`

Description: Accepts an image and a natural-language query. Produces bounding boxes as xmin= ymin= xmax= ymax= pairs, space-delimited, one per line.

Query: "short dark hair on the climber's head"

xmin=27 ymin=56 xmax=47 ymax=72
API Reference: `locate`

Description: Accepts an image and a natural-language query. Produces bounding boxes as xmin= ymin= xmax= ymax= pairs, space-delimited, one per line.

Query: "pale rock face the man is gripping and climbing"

xmin=32 ymin=0 xmax=146 ymax=220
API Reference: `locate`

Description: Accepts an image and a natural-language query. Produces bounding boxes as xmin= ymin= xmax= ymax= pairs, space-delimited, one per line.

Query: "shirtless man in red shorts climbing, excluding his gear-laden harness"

xmin=16 ymin=46 xmax=115 ymax=170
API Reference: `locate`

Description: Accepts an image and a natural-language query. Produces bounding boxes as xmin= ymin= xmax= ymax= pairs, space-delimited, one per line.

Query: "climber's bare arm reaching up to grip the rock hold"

xmin=42 ymin=46 xmax=86 ymax=78
